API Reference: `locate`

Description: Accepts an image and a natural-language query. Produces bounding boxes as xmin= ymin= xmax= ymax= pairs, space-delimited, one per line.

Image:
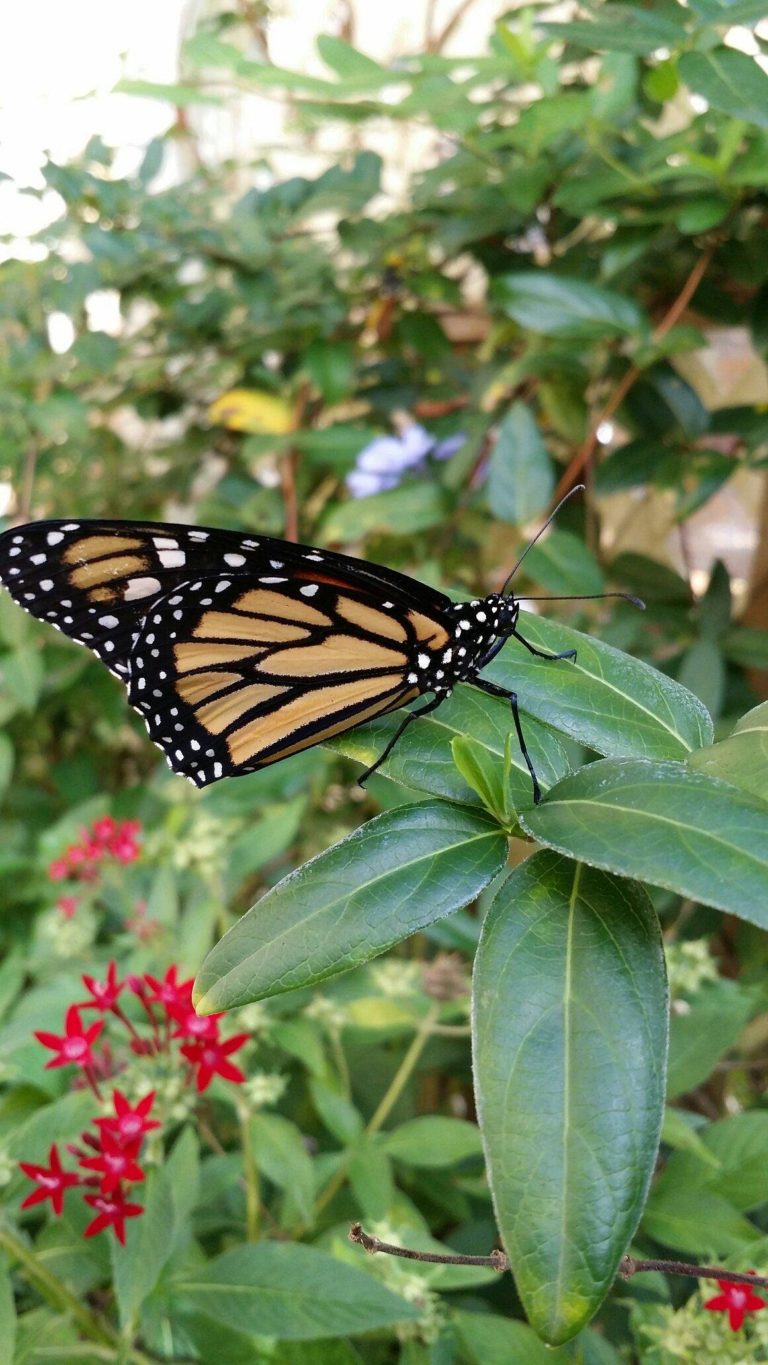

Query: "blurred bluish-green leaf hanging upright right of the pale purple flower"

xmin=487 ymin=403 xmax=555 ymax=526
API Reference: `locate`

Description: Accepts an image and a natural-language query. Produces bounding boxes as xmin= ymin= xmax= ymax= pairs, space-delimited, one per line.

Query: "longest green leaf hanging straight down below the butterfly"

xmin=473 ymin=852 xmax=667 ymax=1345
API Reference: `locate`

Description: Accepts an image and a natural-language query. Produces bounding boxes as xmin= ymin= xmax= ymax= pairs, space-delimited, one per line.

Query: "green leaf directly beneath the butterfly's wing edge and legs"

xmin=330 ymin=687 xmax=569 ymax=809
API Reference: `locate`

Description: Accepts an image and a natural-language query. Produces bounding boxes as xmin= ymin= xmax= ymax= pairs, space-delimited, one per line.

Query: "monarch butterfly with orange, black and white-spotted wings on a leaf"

xmin=0 ymin=502 xmax=638 ymax=801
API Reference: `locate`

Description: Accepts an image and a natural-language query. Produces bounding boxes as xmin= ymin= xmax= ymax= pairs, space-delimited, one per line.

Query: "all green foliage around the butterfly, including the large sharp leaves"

xmin=0 ymin=0 xmax=768 ymax=1365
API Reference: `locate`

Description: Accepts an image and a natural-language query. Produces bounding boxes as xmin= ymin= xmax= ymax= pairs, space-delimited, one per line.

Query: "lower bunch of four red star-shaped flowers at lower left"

xmin=19 ymin=1091 xmax=160 ymax=1244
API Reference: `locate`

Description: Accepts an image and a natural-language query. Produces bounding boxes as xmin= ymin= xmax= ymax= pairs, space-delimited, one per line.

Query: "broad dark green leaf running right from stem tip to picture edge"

xmin=518 ymin=759 xmax=768 ymax=928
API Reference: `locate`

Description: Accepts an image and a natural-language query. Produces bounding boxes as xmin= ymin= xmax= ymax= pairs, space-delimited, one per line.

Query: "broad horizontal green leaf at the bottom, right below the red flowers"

xmin=173 ymin=1242 xmax=419 ymax=1340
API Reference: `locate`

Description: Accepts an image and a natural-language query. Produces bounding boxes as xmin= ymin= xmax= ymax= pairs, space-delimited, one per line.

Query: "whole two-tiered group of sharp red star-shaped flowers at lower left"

xmin=20 ymin=962 xmax=250 ymax=1242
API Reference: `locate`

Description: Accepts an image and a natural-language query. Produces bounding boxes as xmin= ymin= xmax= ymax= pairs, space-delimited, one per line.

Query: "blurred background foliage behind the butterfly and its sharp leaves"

xmin=0 ymin=0 xmax=768 ymax=1365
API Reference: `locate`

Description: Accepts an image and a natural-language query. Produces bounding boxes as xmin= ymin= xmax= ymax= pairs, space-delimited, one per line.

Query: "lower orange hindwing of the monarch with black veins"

xmin=128 ymin=567 xmax=419 ymax=786
